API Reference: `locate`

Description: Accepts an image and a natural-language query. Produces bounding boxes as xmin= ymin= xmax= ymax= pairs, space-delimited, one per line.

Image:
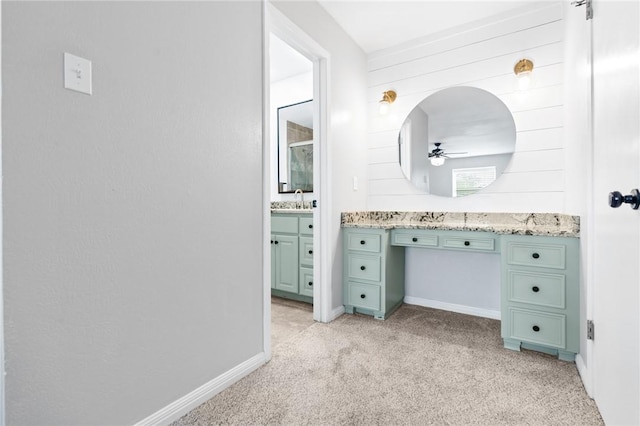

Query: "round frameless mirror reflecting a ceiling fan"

xmin=398 ymin=87 xmax=516 ymax=197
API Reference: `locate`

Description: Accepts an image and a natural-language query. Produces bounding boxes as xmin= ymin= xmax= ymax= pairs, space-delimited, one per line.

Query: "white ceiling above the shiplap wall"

xmin=318 ymin=0 xmax=532 ymax=53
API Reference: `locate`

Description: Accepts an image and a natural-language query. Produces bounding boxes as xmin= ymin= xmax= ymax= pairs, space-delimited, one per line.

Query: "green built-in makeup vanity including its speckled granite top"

xmin=342 ymin=212 xmax=580 ymax=361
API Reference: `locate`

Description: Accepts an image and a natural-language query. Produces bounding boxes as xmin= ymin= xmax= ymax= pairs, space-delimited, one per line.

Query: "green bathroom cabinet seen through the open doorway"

xmin=271 ymin=213 xmax=313 ymax=303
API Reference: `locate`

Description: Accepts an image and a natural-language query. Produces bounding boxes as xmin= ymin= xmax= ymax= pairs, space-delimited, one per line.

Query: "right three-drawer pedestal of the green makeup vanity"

xmin=501 ymin=235 xmax=580 ymax=361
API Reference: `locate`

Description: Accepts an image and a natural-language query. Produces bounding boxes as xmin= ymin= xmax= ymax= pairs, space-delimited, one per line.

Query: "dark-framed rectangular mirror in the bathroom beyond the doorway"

xmin=278 ymin=100 xmax=313 ymax=193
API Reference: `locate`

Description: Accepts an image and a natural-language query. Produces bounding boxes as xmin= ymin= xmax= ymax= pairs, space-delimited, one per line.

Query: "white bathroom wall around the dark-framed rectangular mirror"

xmin=269 ymin=71 xmax=314 ymax=201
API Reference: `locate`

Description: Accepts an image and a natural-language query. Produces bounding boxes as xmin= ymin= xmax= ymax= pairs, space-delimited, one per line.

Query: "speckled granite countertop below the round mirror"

xmin=341 ymin=211 xmax=580 ymax=238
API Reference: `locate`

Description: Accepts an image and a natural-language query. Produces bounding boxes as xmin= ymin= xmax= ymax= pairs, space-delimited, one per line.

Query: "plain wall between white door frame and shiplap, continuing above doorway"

xmin=272 ymin=1 xmax=367 ymax=309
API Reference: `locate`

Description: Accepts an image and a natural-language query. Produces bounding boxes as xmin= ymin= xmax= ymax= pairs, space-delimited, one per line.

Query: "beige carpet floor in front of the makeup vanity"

xmin=174 ymin=305 xmax=603 ymax=426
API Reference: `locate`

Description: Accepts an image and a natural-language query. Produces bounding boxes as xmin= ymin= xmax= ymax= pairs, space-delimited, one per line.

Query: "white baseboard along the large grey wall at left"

xmin=134 ymin=352 xmax=266 ymax=426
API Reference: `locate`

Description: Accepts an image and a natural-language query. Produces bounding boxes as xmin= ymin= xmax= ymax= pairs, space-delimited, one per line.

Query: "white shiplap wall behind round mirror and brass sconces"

xmin=367 ymin=2 xmax=565 ymax=213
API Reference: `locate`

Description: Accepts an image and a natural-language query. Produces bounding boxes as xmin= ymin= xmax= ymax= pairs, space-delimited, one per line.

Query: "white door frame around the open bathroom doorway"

xmin=262 ymin=1 xmax=331 ymax=360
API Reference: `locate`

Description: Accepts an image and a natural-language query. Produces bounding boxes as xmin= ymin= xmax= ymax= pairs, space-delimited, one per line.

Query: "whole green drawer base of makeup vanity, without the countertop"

xmin=343 ymin=228 xmax=580 ymax=361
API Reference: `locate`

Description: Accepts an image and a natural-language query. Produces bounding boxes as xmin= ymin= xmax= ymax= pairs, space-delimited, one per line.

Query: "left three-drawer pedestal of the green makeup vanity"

xmin=343 ymin=228 xmax=404 ymax=319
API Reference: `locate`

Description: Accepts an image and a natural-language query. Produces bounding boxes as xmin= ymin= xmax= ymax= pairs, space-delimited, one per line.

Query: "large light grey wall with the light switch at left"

xmin=2 ymin=2 xmax=264 ymax=425
